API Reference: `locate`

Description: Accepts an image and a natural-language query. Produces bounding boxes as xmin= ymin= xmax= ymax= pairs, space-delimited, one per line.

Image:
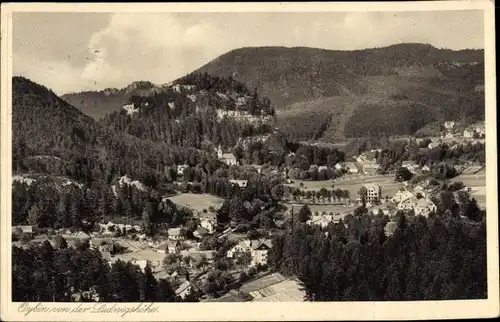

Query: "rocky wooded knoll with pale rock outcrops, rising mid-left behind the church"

xmin=102 ymin=74 xmax=274 ymax=148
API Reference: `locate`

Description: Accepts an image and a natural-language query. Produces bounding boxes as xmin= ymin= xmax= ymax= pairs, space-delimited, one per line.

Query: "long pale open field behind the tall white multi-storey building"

xmin=288 ymin=175 xmax=402 ymax=199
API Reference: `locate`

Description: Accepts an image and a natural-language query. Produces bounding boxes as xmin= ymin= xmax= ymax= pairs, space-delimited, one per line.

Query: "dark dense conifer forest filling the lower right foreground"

xmin=269 ymin=205 xmax=487 ymax=301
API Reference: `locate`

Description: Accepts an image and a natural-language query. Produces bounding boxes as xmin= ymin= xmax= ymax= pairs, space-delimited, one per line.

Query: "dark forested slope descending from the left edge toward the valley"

xmin=12 ymin=77 xmax=227 ymax=186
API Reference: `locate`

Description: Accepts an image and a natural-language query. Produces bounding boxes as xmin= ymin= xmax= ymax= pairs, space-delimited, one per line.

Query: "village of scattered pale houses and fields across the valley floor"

xmin=12 ymin=115 xmax=485 ymax=302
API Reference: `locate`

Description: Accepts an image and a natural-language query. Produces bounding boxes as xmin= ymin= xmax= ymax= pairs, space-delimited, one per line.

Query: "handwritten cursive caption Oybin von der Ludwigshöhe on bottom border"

xmin=18 ymin=302 xmax=159 ymax=317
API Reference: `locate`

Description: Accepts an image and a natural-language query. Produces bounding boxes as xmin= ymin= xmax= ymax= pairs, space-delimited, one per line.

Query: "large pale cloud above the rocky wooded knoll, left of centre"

xmin=81 ymin=14 xmax=227 ymax=87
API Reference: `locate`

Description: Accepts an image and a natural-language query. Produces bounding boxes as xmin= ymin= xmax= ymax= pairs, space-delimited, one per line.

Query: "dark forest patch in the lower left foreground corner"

xmin=12 ymin=243 xmax=193 ymax=302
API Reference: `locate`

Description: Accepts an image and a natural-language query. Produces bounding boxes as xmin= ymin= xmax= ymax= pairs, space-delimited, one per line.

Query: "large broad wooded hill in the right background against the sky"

xmin=193 ymin=44 xmax=484 ymax=141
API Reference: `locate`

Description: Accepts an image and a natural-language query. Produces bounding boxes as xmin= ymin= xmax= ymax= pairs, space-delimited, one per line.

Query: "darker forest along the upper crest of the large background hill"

xmin=198 ymin=44 xmax=484 ymax=108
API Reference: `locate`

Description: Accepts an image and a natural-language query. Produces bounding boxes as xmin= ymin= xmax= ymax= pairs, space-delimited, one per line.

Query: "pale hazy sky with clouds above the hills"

xmin=12 ymin=10 xmax=484 ymax=95
